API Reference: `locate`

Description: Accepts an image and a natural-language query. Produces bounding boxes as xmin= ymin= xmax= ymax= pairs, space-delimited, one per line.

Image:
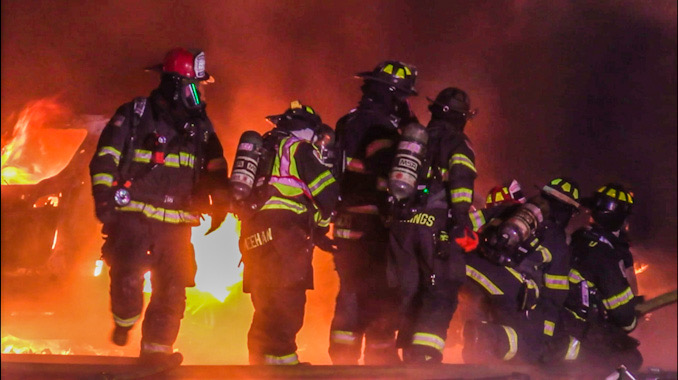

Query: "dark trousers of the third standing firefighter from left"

xmin=329 ymin=214 xmax=400 ymax=365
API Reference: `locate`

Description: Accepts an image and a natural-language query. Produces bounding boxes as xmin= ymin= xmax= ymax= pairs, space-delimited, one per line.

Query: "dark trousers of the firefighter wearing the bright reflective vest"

xmin=240 ymin=210 xmax=313 ymax=365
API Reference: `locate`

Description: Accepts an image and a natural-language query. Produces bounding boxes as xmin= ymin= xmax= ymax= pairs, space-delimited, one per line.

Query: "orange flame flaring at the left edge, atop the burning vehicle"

xmin=1 ymin=98 xmax=87 ymax=185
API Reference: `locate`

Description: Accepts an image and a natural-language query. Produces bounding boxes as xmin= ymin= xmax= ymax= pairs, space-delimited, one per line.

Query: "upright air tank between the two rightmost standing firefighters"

xmin=388 ymin=123 xmax=428 ymax=201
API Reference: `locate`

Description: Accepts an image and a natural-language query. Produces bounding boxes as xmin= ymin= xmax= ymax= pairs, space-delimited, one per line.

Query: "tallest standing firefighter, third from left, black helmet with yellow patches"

xmin=329 ymin=61 xmax=417 ymax=364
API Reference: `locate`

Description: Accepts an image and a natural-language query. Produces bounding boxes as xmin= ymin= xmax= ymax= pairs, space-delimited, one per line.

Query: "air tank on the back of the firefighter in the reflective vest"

xmin=229 ymin=131 xmax=264 ymax=201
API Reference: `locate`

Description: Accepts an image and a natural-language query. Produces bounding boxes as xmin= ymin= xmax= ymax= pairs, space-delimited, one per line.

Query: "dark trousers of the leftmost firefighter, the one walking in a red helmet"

xmin=102 ymin=214 xmax=197 ymax=353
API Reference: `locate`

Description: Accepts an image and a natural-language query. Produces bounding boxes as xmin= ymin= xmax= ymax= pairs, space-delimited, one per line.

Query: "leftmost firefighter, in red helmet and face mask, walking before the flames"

xmin=89 ymin=48 xmax=228 ymax=361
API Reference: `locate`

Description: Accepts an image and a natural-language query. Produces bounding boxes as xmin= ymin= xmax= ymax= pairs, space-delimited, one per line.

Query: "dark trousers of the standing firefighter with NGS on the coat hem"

xmin=389 ymin=209 xmax=465 ymax=362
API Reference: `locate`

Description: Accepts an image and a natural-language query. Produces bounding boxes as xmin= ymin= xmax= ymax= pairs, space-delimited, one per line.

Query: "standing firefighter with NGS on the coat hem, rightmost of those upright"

xmin=390 ymin=87 xmax=478 ymax=364
